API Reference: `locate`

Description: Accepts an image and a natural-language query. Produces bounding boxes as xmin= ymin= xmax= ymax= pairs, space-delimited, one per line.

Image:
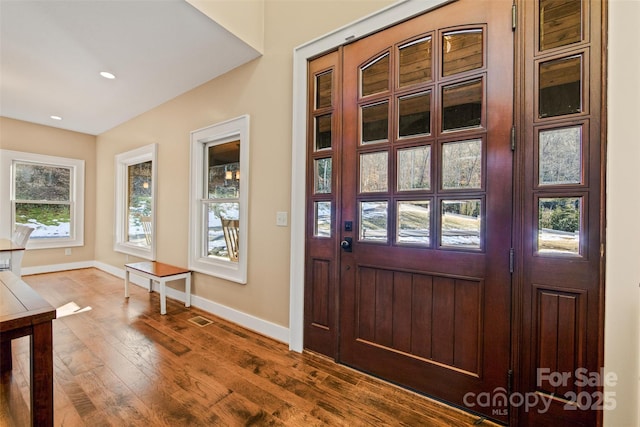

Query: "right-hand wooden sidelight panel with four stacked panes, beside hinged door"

xmin=514 ymin=0 xmax=604 ymax=426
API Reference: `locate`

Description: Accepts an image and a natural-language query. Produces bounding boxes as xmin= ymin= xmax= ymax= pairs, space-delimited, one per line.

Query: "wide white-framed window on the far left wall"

xmin=0 ymin=150 xmax=84 ymax=249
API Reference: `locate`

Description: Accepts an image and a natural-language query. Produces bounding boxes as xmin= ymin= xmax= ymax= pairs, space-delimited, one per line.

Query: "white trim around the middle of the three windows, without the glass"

xmin=113 ymin=144 xmax=158 ymax=261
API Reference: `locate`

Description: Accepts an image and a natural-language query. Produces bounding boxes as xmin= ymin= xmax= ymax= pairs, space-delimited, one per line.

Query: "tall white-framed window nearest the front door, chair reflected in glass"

xmin=189 ymin=115 xmax=249 ymax=283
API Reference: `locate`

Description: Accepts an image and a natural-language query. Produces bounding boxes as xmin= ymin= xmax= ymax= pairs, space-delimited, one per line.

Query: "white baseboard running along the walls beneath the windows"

xmin=22 ymin=261 xmax=289 ymax=344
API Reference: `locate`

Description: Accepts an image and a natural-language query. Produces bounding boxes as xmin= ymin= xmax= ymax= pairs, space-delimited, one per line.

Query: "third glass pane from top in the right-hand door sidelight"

xmin=538 ymin=126 xmax=582 ymax=185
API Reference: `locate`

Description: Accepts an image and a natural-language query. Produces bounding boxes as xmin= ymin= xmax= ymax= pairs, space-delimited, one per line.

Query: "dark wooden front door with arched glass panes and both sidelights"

xmin=304 ymin=0 xmax=604 ymax=425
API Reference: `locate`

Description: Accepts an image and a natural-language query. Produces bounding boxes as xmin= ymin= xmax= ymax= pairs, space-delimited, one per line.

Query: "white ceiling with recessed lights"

xmin=0 ymin=0 xmax=259 ymax=135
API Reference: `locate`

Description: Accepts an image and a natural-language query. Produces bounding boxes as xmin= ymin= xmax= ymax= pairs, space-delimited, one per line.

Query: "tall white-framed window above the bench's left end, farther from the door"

xmin=114 ymin=144 xmax=158 ymax=260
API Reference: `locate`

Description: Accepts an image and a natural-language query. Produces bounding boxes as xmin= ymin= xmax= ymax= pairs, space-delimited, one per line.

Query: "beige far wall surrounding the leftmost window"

xmin=0 ymin=117 xmax=96 ymax=267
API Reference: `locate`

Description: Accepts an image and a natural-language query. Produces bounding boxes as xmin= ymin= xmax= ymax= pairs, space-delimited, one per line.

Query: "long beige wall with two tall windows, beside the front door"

xmin=96 ymin=1 xmax=391 ymax=327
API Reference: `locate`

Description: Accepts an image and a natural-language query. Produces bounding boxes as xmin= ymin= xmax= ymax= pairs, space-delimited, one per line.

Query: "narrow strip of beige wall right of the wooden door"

xmin=604 ymin=0 xmax=640 ymax=427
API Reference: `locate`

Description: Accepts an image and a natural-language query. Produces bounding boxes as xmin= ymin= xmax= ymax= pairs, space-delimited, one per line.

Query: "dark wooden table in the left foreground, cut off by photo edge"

xmin=0 ymin=271 xmax=56 ymax=427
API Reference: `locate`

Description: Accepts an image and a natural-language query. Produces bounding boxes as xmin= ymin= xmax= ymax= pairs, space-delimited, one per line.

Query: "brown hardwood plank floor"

xmin=0 ymin=269 xmax=500 ymax=427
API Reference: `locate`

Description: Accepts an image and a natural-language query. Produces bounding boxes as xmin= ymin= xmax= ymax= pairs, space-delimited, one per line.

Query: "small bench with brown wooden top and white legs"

xmin=124 ymin=261 xmax=191 ymax=314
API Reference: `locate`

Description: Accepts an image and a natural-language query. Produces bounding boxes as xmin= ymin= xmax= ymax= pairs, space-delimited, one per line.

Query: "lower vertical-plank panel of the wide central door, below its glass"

xmin=355 ymin=267 xmax=482 ymax=375
